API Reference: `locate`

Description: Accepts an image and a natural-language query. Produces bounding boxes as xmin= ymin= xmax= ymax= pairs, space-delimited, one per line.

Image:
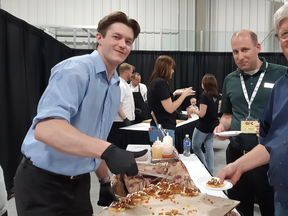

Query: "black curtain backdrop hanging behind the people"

xmin=0 ymin=9 xmax=288 ymax=192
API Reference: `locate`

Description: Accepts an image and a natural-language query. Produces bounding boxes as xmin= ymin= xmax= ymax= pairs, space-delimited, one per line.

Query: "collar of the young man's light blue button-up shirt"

xmin=90 ymin=50 xmax=120 ymax=85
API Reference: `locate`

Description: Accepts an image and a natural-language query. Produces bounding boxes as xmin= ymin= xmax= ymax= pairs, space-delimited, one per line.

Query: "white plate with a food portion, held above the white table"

xmin=198 ymin=176 xmax=233 ymax=190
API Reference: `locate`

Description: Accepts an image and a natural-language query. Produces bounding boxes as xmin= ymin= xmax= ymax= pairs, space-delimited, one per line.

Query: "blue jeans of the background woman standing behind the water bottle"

xmin=192 ymin=128 xmax=214 ymax=174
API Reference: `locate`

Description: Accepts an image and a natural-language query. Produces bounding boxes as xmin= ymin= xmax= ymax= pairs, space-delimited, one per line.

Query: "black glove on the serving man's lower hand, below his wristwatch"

xmin=97 ymin=182 xmax=118 ymax=206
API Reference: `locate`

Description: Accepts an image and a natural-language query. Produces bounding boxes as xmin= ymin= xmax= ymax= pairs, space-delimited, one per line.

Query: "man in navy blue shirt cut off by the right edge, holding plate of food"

xmin=217 ymin=4 xmax=288 ymax=216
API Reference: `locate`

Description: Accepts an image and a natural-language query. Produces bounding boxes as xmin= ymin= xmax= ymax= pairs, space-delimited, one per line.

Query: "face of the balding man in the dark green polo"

xmin=231 ymin=33 xmax=261 ymax=72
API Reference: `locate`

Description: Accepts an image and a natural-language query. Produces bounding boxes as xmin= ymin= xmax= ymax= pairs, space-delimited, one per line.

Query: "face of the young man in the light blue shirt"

xmin=96 ymin=22 xmax=134 ymax=69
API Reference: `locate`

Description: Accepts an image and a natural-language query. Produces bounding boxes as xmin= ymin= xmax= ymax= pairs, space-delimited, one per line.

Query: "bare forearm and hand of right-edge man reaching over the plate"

xmin=217 ymin=144 xmax=270 ymax=185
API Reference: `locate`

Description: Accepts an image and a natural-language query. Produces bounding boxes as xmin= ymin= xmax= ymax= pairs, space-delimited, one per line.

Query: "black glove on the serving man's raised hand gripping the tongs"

xmin=101 ymin=144 xmax=148 ymax=176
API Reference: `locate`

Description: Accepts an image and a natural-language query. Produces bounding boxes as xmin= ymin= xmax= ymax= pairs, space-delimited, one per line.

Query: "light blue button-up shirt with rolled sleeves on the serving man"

xmin=22 ymin=51 xmax=121 ymax=176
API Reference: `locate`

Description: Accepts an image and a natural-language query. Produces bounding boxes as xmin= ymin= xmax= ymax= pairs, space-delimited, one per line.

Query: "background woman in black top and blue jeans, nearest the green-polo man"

xmin=187 ymin=74 xmax=219 ymax=174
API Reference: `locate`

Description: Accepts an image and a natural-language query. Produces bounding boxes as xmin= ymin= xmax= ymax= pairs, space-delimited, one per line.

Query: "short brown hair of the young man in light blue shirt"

xmin=96 ymin=11 xmax=140 ymax=49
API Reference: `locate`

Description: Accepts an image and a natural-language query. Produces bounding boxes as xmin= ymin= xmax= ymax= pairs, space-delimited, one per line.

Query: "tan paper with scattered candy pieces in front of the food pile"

xmin=94 ymin=193 xmax=239 ymax=216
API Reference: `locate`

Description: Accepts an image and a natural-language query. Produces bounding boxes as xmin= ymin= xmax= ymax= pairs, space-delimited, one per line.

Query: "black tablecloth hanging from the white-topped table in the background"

xmin=115 ymin=120 xmax=198 ymax=154
